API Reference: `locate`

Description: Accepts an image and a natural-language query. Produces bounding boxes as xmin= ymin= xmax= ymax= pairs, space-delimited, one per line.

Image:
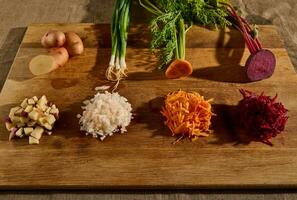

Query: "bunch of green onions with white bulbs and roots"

xmin=106 ymin=0 xmax=132 ymax=82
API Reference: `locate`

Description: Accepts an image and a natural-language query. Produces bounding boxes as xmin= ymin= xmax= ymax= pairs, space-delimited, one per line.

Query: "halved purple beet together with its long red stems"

xmin=222 ymin=3 xmax=276 ymax=81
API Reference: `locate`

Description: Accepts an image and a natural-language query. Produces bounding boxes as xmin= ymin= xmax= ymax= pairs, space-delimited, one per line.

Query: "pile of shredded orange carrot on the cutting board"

xmin=161 ymin=90 xmax=214 ymax=140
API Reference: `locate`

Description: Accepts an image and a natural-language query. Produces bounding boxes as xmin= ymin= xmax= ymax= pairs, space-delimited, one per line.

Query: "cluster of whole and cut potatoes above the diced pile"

xmin=29 ymin=30 xmax=84 ymax=75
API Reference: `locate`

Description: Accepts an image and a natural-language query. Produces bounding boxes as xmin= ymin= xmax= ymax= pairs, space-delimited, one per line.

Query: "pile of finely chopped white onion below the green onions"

xmin=77 ymin=91 xmax=132 ymax=140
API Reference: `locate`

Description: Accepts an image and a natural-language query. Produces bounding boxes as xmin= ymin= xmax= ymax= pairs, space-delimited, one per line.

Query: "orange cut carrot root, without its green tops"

xmin=165 ymin=59 xmax=193 ymax=79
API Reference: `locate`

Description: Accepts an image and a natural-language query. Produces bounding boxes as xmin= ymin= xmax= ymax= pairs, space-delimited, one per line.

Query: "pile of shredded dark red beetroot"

xmin=238 ymin=89 xmax=288 ymax=145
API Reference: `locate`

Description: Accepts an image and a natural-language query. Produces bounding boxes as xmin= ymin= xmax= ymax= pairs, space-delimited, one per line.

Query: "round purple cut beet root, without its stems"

xmin=245 ymin=49 xmax=276 ymax=81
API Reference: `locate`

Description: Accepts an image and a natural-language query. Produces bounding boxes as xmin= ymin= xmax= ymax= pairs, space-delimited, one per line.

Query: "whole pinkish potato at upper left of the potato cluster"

xmin=41 ymin=30 xmax=66 ymax=48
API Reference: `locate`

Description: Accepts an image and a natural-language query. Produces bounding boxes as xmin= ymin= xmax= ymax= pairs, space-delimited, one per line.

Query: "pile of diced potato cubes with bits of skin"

xmin=5 ymin=95 xmax=59 ymax=144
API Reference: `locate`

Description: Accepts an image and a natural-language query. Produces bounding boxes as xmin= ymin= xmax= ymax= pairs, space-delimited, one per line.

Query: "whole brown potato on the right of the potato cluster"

xmin=65 ymin=32 xmax=84 ymax=56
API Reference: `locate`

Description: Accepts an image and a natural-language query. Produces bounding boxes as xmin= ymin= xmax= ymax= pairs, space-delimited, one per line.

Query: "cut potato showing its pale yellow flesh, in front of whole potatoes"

xmin=29 ymin=47 xmax=69 ymax=75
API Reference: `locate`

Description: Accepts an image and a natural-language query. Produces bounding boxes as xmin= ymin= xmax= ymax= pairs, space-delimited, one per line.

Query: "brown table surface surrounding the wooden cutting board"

xmin=0 ymin=0 xmax=297 ymax=199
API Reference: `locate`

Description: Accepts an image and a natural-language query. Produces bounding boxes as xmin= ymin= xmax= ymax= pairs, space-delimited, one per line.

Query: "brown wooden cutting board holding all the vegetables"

xmin=0 ymin=24 xmax=297 ymax=189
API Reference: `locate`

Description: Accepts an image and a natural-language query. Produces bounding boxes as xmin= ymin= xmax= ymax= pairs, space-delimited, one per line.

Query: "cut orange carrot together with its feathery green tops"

xmin=139 ymin=0 xmax=230 ymax=78
